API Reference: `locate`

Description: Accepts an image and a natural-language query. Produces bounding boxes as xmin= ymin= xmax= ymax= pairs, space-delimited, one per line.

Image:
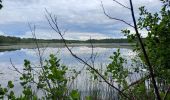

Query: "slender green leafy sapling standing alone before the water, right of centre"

xmin=105 ymin=49 xmax=128 ymax=87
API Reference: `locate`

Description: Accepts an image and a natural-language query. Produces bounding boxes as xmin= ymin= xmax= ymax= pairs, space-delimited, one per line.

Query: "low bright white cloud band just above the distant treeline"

xmin=18 ymin=30 xmax=110 ymax=40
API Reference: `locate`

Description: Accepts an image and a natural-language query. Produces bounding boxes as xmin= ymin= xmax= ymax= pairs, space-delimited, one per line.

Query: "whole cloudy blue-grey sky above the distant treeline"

xmin=0 ymin=0 xmax=161 ymax=40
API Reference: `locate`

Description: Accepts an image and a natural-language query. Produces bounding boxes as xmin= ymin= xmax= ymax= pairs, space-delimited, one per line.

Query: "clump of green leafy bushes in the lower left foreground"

xmin=0 ymin=55 xmax=80 ymax=100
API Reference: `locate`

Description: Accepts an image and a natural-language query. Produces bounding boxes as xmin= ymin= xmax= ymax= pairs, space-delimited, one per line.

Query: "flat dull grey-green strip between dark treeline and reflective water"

xmin=0 ymin=43 xmax=134 ymax=51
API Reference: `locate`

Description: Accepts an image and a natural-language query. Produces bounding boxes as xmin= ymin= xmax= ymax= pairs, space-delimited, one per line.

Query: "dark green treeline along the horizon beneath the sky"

xmin=0 ymin=36 xmax=128 ymax=43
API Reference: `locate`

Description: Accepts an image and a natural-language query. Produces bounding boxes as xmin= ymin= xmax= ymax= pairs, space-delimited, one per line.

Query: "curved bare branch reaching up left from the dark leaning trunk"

xmin=101 ymin=2 xmax=134 ymax=28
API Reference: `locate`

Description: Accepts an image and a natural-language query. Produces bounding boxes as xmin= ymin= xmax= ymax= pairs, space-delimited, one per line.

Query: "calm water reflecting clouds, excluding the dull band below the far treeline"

xmin=0 ymin=46 xmax=136 ymax=98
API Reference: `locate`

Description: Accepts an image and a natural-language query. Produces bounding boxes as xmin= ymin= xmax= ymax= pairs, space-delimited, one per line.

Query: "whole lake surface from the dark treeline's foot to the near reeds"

xmin=0 ymin=44 xmax=141 ymax=99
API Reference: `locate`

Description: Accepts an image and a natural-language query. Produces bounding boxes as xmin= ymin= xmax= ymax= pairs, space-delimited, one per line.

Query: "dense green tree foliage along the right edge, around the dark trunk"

xmin=122 ymin=0 xmax=170 ymax=99
